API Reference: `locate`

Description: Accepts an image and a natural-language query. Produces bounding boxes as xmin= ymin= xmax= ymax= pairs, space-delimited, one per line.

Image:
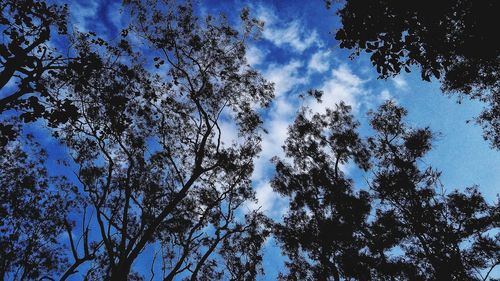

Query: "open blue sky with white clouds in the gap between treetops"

xmin=7 ymin=0 xmax=500 ymax=280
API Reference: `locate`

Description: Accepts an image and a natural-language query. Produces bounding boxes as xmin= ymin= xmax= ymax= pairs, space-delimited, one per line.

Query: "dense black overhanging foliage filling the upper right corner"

xmin=327 ymin=0 xmax=500 ymax=148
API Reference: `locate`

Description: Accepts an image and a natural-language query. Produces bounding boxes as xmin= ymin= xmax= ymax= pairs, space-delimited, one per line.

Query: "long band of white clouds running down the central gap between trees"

xmin=240 ymin=7 xmax=365 ymax=218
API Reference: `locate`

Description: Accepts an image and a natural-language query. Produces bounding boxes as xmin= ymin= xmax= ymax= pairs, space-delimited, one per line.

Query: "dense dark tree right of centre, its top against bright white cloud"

xmin=272 ymin=103 xmax=371 ymax=281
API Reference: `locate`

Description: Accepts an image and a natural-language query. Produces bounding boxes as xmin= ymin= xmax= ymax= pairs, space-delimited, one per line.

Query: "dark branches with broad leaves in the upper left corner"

xmin=0 ymin=0 xmax=84 ymax=147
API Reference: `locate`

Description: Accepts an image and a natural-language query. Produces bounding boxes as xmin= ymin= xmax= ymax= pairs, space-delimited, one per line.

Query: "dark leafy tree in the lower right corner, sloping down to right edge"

xmin=368 ymin=102 xmax=500 ymax=280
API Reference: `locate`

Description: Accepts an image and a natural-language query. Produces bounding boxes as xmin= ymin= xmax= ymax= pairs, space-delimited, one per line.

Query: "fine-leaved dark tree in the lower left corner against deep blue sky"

xmin=0 ymin=136 xmax=77 ymax=280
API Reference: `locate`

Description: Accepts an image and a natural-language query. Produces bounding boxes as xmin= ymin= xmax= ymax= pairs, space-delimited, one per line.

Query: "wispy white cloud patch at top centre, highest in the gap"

xmin=257 ymin=6 xmax=322 ymax=53
